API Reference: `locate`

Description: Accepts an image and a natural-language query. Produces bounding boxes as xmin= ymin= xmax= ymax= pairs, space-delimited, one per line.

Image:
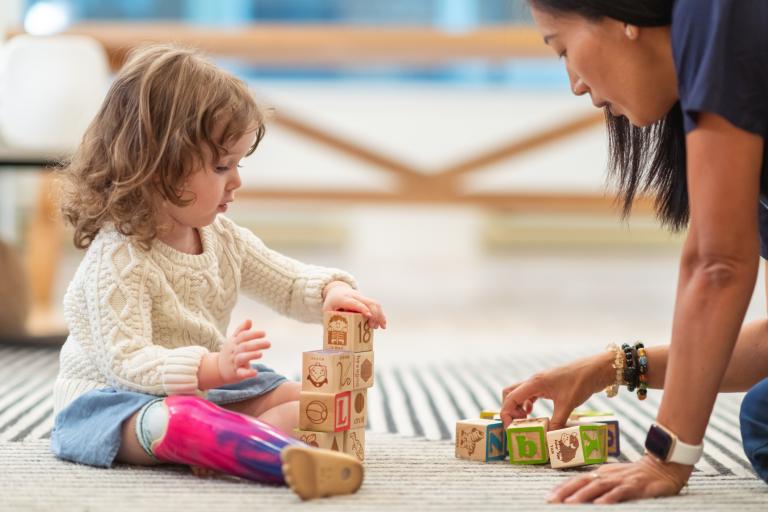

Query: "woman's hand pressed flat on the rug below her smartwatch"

xmin=548 ymin=455 xmax=693 ymax=504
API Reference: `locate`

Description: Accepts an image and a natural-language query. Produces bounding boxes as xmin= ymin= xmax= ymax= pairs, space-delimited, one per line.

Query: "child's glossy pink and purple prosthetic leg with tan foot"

xmin=136 ymin=396 xmax=363 ymax=499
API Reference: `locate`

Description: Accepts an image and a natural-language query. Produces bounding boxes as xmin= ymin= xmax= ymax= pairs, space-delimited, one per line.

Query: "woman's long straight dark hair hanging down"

xmin=528 ymin=0 xmax=689 ymax=231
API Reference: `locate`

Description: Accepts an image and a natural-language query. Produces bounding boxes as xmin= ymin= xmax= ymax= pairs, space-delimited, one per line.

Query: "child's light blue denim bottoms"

xmin=51 ymin=364 xmax=287 ymax=467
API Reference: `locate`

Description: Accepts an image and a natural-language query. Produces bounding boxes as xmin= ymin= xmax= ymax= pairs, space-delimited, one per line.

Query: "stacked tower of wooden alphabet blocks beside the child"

xmin=295 ymin=311 xmax=373 ymax=461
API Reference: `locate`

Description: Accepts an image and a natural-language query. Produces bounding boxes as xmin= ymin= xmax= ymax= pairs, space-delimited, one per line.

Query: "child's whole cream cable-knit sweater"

xmin=53 ymin=215 xmax=356 ymax=412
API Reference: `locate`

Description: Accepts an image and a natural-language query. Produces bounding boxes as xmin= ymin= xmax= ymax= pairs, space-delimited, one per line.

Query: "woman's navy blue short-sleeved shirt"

xmin=672 ymin=0 xmax=768 ymax=258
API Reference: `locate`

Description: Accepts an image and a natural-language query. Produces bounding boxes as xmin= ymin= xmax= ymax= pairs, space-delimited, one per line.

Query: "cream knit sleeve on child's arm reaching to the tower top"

xmin=219 ymin=216 xmax=357 ymax=322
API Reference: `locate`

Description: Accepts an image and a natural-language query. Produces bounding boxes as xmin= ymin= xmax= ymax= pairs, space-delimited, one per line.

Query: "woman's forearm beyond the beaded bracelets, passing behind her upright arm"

xmin=646 ymin=319 xmax=768 ymax=393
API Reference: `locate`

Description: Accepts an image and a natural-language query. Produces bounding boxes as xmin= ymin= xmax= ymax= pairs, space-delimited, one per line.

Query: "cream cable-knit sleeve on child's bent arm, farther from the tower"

xmin=64 ymin=238 xmax=208 ymax=395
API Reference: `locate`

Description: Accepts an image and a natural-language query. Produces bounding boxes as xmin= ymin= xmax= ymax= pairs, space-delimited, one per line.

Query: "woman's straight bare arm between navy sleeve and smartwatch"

xmin=657 ymin=113 xmax=763 ymax=444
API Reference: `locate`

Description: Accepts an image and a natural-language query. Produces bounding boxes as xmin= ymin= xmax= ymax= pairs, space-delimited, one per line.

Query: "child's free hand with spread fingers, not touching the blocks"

xmin=218 ymin=320 xmax=271 ymax=383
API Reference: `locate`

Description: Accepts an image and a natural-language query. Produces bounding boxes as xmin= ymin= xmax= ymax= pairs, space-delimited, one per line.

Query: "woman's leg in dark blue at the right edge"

xmin=739 ymin=379 xmax=768 ymax=482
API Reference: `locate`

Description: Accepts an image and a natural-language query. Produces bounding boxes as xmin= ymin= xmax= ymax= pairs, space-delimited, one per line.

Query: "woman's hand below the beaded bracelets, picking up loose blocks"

xmin=501 ymin=352 xmax=616 ymax=430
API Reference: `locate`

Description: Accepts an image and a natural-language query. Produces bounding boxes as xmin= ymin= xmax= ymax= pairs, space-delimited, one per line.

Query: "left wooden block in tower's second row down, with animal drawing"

xmin=301 ymin=350 xmax=352 ymax=393
